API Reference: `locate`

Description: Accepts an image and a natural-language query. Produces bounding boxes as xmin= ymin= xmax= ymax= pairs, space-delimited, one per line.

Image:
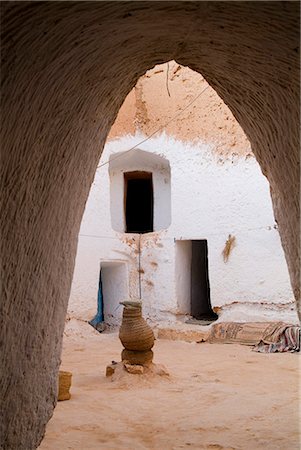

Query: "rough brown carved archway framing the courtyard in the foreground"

xmin=0 ymin=2 xmax=299 ymax=449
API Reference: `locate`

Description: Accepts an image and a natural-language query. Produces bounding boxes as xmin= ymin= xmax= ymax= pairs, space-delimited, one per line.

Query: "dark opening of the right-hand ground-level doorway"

xmin=191 ymin=240 xmax=218 ymax=320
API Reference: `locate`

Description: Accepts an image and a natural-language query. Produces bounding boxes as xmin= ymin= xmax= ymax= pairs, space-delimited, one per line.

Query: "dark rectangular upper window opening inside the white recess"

xmin=124 ymin=171 xmax=154 ymax=233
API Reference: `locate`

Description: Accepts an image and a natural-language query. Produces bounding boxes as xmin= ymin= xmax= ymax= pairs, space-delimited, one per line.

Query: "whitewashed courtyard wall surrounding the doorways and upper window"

xmin=69 ymin=134 xmax=297 ymax=323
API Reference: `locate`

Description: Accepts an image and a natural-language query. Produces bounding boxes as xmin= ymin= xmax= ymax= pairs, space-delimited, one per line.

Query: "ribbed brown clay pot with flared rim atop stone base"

xmin=119 ymin=301 xmax=155 ymax=352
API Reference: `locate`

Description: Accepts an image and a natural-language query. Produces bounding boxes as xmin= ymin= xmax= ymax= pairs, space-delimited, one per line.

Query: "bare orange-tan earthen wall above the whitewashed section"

xmin=108 ymin=61 xmax=252 ymax=159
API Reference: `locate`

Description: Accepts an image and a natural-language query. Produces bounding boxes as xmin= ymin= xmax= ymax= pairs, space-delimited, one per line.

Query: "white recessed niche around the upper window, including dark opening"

xmin=109 ymin=149 xmax=171 ymax=233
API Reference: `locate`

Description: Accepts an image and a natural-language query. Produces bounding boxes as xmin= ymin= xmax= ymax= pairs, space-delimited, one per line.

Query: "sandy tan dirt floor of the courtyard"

xmin=39 ymin=324 xmax=300 ymax=450
